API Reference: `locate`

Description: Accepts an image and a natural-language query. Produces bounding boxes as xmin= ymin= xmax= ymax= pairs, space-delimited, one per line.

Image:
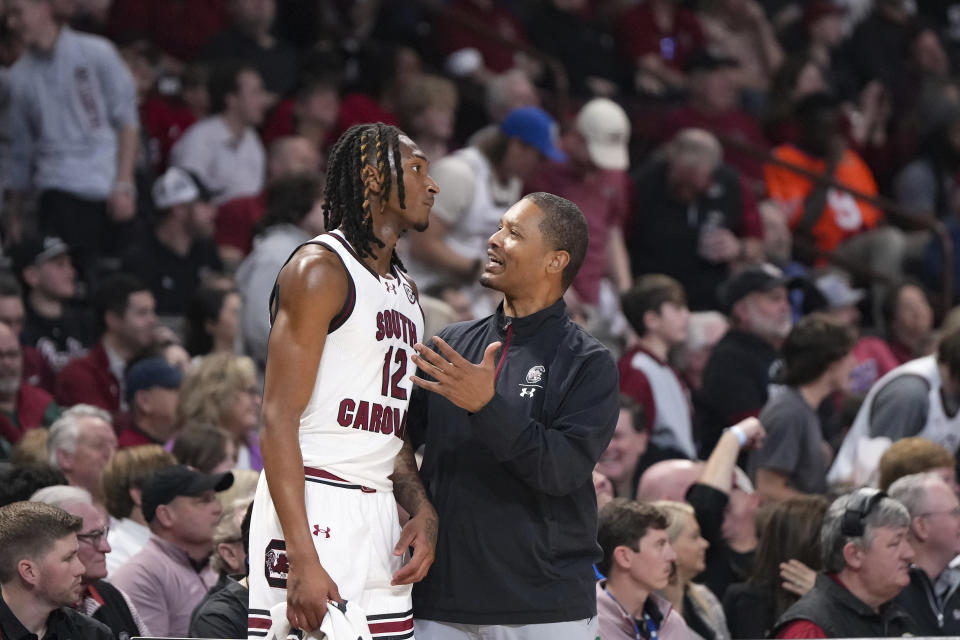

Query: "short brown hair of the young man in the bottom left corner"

xmin=0 ymin=502 xmax=83 ymax=584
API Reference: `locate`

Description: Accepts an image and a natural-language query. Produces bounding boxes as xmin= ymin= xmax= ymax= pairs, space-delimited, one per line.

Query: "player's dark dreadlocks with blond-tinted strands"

xmin=323 ymin=122 xmax=406 ymax=269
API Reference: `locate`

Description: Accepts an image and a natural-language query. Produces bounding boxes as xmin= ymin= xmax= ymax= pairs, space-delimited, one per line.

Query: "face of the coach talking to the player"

xmin=480 ymin=200 xmax=557 ymax=296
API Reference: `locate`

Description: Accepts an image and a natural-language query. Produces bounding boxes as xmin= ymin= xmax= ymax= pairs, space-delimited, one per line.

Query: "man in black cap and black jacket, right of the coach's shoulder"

xmin=694 ymin=264 xmax=792 ymax=458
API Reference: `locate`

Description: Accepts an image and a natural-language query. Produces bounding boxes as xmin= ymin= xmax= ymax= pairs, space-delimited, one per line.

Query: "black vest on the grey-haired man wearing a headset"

xmin=770 ymin=573 xmax=917 ymax=638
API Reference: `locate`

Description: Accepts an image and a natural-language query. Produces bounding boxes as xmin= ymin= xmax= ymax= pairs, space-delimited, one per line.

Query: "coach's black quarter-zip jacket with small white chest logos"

xmin=408 ymin=300 xmax=619 ymax=624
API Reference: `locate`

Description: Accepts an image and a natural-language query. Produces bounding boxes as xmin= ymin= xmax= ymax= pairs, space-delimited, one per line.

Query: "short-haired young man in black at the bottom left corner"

xmin=0 ymin=502 xmax=113 ymax=640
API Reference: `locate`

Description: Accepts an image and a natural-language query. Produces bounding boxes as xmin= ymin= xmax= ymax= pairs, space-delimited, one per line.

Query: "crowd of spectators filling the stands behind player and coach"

xmin=0 ymin=0 xmax=960 ymax=640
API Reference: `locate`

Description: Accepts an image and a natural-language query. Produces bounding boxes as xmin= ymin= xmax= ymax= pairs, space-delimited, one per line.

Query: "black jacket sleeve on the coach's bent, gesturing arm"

xmin=470 ymin=352 xmax=620 ymax=496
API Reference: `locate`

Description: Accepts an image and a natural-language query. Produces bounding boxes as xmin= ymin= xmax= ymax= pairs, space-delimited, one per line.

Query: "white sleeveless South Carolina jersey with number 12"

xmin=288 ymin=231 xmax=423 ymax=491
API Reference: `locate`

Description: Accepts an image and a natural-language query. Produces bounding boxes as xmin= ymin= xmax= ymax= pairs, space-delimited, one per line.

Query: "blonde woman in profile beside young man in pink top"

xmin=653 ymin=500 xmax=730 ymax=640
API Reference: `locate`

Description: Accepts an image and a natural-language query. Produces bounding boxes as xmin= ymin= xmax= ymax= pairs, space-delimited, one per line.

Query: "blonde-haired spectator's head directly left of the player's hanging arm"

xmin=177 ymin=353 xmax=263 ymax=471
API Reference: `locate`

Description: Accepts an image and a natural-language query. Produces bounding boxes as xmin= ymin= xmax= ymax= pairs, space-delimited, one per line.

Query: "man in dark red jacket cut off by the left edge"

xmin=0 ymin=323 xmax=60 ymax=458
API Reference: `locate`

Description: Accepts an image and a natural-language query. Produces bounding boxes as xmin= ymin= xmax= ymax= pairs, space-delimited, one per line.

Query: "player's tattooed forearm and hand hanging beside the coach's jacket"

xmin=390 ymin=442 xmax=440 ymax=585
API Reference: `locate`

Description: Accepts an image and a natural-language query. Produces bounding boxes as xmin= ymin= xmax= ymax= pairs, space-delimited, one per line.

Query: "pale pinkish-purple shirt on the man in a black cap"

xmin=110 ymin=535 xmax=217 ymax=638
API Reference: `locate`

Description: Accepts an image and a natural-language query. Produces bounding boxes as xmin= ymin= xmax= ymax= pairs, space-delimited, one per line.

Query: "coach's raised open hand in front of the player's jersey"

xmin=410 ymin=337 xmax=502 ymax=413
